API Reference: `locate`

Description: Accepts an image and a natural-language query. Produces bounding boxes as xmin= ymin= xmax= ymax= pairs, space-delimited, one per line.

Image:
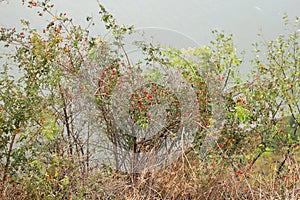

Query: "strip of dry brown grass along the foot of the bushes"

xmin=2 ymin=150 xmax=300 ymax=200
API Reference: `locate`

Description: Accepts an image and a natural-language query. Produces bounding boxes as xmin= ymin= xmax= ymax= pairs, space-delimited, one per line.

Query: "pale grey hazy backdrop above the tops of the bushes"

xmin=0 ymin=0 xmax=300 ymax=74
